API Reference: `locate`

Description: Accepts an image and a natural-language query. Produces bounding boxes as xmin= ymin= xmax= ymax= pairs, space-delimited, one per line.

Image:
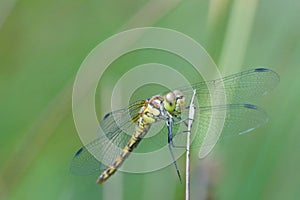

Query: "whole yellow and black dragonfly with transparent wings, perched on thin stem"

xmin=70 ymin=68 xmax=279 ymax=184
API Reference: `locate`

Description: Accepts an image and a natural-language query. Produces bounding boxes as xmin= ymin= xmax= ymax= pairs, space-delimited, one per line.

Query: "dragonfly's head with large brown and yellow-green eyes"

xmin=163 ymin=90 xmax=185 ymax=113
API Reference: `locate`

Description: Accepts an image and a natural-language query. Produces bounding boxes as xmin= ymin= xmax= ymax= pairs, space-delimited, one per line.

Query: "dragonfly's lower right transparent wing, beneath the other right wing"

xmin=169 ymin=104 xmax=268 ymax=148
